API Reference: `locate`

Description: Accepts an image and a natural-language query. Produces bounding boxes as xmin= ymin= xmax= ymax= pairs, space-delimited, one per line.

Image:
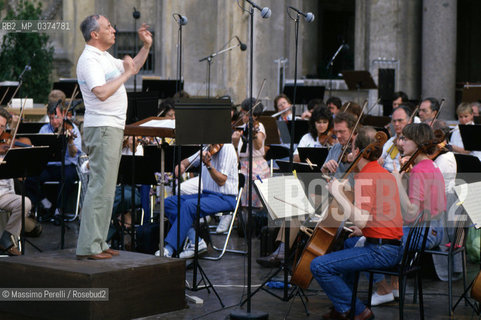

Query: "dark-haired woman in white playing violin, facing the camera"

xmin=294 ymin=104 xmax=337 ymax=162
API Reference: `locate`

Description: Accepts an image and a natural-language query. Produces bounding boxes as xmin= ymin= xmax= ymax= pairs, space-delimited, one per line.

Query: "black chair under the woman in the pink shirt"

xmin=425 ymin=216 xmax=466 ymax=316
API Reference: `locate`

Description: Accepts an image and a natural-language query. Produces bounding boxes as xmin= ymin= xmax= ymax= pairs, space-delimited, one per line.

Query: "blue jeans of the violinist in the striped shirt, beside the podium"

xmin=165 ymin=191 xmax=236 ymax=250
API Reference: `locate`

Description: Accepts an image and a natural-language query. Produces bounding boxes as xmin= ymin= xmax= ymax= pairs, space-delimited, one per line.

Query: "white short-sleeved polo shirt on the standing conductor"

xmin=77 ymin=44 xmax=127 ymax=129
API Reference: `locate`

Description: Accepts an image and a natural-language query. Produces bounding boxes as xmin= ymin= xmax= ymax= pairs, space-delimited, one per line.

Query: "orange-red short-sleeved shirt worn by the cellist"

xmin=354 ymin=161 xmax=403 ymax=240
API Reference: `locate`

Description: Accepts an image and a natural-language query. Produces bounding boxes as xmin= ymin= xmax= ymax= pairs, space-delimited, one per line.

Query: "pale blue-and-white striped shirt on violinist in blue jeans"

xmin=188 ymin=143 xmax=239 ymax=196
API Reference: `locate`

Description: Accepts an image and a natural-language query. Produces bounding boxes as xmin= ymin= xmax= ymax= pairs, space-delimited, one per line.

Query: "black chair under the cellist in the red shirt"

xmin=351 ymin=211 xmax=430 ymax=320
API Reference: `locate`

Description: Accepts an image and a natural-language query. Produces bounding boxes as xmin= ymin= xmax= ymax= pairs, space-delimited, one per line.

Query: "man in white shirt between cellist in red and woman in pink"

xmin=379 ymin=105 xmax=411 ymax=172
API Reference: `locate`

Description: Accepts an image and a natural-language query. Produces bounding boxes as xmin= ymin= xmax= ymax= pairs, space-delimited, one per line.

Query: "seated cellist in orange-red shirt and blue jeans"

xmin=311 ymin=127 xmax=403 ymax=319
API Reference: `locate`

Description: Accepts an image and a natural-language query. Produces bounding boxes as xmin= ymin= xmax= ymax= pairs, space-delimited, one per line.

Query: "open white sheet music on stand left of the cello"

xmin=254 ymin=176 xmax=314 ymax=220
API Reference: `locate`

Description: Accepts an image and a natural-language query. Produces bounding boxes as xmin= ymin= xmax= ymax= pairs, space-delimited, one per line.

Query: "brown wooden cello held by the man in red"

xmin=291 ymin=131 xmax=387 ymax=289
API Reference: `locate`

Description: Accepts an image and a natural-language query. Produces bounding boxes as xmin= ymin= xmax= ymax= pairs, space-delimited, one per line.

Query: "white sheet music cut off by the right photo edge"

xmin=454 ymin=181 xmax=481 ymax=229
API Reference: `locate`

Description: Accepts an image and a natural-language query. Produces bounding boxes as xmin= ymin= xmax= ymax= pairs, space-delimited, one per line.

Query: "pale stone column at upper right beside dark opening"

xmin=422 ymin=0 xmax=457 ymax=119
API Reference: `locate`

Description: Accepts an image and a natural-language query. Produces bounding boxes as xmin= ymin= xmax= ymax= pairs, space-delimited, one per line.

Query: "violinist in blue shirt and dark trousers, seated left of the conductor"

xmin=27 ymin=102 xmax=82 ymax=222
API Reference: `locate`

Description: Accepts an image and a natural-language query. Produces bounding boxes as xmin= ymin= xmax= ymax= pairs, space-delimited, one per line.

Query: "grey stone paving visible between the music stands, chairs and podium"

xmin=16 ymin=221 xmax=479 ymax=320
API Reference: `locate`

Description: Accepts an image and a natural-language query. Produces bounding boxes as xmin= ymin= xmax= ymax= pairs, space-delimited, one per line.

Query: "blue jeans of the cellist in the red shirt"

xmin=311 ymin=240 xmax=403 ymax=315
